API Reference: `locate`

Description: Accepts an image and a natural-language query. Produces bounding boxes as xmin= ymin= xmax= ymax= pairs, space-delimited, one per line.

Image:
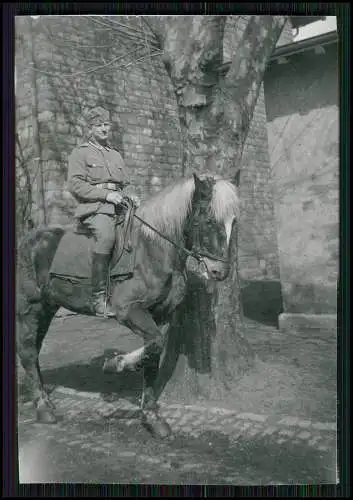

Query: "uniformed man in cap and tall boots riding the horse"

xmin=68 ymin=107 xmax=139 ymax=317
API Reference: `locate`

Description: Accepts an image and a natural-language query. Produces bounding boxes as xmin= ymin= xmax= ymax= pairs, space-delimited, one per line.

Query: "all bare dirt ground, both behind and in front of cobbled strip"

xmin=19 ymin=316 xmax=336 ymax=485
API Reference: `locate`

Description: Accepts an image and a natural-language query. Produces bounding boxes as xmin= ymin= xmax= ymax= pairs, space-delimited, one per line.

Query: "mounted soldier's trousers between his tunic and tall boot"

xmin=82 ymin=214 xmax=117 ymax=255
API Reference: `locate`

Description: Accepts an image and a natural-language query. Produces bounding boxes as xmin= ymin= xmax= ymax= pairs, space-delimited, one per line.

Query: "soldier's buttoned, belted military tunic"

xmin=68 ymin=142 xmax=130 ymax=219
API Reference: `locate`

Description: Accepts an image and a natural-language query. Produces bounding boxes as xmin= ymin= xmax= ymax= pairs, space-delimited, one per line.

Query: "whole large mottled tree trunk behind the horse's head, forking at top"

xmin=148 ymin=16 xmax=286 ymax=402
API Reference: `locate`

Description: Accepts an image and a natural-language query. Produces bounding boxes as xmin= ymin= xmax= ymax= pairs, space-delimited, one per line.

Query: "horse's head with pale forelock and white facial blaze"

xmin=185 ymin=174 xmax=239 ymax=281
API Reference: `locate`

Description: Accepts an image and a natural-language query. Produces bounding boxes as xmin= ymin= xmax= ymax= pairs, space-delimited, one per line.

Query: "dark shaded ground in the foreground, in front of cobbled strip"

xmin=19 ymin=406 xmax=336 ymax=485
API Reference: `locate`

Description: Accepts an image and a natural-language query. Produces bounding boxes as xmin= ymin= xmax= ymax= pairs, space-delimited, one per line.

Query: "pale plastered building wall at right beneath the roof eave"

xmin=265 ymin=45 xmax=339 ymax=314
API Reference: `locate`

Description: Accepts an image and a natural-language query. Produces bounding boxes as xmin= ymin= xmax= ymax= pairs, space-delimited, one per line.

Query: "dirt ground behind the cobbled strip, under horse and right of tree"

xmin=20 ymin=310 xmax=337 ymax=422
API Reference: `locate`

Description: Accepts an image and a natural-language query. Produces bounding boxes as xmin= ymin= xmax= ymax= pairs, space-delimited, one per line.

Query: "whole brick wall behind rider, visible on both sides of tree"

xmin=16 ymin=16 xmax=288 ymax=292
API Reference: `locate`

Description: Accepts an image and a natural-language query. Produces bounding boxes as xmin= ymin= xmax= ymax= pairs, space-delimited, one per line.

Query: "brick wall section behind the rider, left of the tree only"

xmin=16 ymin=16 xmax=181 ymax=227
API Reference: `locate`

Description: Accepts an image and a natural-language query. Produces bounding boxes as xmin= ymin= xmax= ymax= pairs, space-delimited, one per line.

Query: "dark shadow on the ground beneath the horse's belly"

xmin=20 ymin=349 xmax=142 ymax=403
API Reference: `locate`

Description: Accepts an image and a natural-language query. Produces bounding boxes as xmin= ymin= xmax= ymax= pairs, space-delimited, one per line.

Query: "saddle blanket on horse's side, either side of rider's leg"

xmin=49 ymin=232 xmax=135 ymax=279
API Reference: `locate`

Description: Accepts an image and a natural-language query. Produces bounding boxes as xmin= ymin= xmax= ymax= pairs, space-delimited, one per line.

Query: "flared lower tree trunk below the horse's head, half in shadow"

xmin=156 ymin=225 xmax=250 ymax=404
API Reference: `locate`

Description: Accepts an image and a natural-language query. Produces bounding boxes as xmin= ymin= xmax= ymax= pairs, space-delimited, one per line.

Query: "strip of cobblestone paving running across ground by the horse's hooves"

xmin=19 ymin=387 xmax=336 ymax=452
